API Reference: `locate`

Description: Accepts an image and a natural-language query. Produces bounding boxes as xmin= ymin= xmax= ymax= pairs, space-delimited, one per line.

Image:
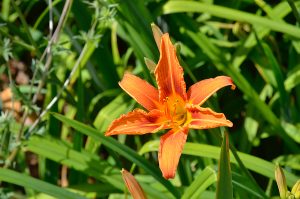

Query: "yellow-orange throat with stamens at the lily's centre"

xmin=164 ymin=96 xmax=187 ymax=126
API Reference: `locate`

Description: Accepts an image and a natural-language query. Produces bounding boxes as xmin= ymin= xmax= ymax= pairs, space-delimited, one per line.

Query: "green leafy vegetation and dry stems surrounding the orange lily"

xmin=0 ymin=0 xmax=300 ymax=199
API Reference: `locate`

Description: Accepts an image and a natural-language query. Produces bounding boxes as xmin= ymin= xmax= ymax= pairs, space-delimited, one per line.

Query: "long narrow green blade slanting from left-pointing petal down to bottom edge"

xmin=52 ymin=113 xmax=180 ymax=198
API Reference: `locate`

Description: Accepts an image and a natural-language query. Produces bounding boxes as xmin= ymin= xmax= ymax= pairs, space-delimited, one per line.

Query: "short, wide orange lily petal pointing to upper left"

xmin=119 ymin=73 xmax=159 ymax=110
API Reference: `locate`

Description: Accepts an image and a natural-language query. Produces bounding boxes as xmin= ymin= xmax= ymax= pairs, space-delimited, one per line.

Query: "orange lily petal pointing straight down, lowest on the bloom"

xmin=158 ymin=128 xmax=188 ymax=179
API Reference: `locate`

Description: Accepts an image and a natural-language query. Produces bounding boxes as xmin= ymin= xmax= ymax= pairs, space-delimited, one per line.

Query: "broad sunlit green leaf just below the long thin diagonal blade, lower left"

xmin=26 ymin=136 xmax=124 ymax=190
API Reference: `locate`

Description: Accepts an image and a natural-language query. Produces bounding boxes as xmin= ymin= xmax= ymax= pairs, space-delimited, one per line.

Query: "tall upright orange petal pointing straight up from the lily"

xmin=154 ymin=33 xmax=187 ymax=102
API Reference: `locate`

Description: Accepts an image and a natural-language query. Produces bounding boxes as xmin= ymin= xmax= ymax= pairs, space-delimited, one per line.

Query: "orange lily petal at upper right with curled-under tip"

xmin=187 ymin=76 xmax=235 ymax=106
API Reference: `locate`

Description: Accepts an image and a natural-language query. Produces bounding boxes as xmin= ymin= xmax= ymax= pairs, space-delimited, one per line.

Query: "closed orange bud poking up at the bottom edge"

xmin=121 ymin=169 xmax=147 ymax=199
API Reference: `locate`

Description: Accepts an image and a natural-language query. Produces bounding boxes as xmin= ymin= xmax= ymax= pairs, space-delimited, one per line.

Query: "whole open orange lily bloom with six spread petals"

xmin=105 ymin=24 xmax=235 ymax=179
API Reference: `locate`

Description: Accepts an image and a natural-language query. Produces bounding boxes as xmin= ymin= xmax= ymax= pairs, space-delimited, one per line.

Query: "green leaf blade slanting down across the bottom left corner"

xmin=0 ymin=168 xmax=85 ymax=199
